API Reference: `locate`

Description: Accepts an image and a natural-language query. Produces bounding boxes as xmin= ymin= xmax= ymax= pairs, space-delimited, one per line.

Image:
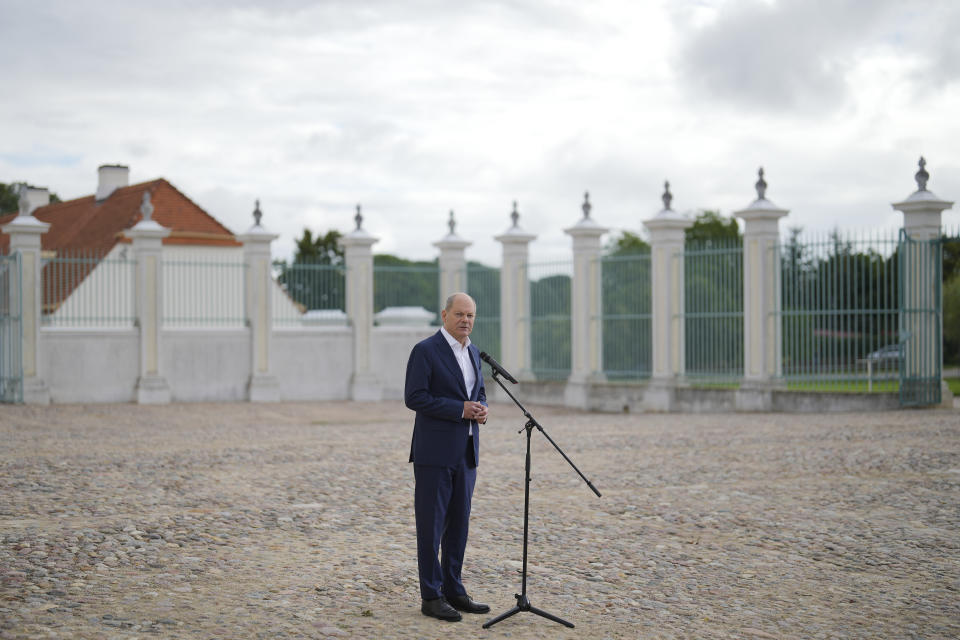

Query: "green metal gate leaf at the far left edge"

xmin=0 ymin=253 xmax=23 ymax=403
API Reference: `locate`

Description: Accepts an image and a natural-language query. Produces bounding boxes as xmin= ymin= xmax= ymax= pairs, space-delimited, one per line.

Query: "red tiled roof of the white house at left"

xmin=0 ymin=178 xmax=241 ymax=255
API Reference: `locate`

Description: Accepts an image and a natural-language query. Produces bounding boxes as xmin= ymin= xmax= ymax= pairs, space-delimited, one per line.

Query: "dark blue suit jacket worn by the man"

xmin=403 ymin=331 xmax=487 ymax=466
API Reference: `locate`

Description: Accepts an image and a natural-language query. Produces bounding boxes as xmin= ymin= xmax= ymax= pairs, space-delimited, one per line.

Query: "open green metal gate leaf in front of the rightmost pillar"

xmin=898 ymin=229 xmax=943 ymax=407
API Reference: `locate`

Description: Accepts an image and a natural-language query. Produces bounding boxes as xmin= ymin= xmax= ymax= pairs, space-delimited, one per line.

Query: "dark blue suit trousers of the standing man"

xmin=413 ymin=437 xmax=477 ymax=600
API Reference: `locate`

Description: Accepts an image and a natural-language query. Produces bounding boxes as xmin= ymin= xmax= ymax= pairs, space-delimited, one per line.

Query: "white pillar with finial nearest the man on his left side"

xmin=340 ymin=205 xmax=383 ymax=400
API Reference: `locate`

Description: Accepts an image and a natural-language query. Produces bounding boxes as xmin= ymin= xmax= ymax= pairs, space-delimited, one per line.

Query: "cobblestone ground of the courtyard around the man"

xmin=0 ymin=402 xmax=960 ymax=639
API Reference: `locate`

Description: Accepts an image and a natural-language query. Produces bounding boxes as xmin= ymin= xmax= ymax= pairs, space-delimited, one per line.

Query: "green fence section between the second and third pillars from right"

xmin=678 ymin=240 xmax=743 ymax=384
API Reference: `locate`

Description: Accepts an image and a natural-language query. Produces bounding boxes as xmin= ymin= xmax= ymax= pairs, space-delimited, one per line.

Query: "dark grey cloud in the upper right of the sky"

xmin=677 ymin=0 xmax=917 ymax=113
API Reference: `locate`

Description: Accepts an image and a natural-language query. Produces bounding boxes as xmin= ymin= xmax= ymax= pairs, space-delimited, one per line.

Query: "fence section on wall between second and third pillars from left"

xmin=161 ymin=254 xmax=246 ymax=328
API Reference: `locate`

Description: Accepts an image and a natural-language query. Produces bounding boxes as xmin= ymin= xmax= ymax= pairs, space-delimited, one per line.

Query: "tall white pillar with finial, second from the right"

xmin=734 ymin=168 xmax=789 ymax=411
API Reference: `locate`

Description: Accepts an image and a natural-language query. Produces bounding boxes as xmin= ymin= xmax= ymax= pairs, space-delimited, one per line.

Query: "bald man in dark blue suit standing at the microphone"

xmin=403 ymin=293 xmax=490 ymax=621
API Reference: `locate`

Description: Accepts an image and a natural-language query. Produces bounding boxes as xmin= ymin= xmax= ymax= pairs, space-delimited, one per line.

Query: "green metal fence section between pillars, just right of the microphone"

xmin=526 ymin=261 xmax=573 ymax=380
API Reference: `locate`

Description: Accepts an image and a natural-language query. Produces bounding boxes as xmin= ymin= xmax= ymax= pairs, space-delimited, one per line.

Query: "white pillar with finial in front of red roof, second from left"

xmin=126 ymin=191 xmax=170 ymax=404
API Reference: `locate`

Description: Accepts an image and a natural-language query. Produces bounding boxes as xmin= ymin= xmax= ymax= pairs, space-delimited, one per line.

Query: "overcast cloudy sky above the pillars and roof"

xmin=0 ymin=0 xmax=960 ymax=264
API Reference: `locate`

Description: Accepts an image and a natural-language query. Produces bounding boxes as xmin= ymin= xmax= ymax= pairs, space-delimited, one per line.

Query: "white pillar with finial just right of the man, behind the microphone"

xmin=494 ymin=202 xmax=537 ymax=381
